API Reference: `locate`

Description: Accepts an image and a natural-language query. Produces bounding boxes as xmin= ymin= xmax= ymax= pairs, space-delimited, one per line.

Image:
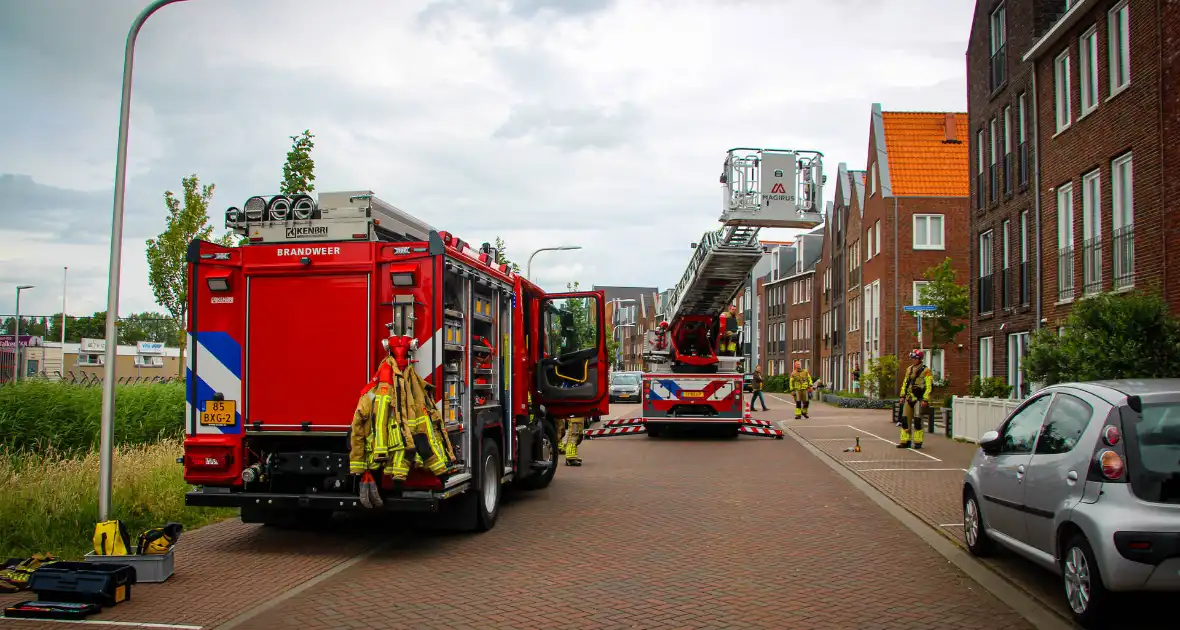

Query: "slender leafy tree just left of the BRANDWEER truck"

xmin=148 ymin=173 xmax=220 ymax=374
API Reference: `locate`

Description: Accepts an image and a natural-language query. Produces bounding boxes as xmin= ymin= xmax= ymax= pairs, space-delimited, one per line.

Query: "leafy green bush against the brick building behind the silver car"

xmin=1023 ymin=291 xmax=1180 ymax=385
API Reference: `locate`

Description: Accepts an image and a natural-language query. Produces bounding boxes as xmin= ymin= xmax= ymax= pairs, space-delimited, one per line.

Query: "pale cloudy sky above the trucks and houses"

xmin=0 ymin=0 xmax=974 ymax=314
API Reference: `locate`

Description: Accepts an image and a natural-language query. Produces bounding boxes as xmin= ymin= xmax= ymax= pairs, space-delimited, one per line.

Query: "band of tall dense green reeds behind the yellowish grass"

xmin=0 ymin=380 xmax=184 ymax=457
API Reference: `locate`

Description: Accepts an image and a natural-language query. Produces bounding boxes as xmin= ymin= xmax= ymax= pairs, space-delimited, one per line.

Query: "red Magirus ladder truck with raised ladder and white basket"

xmin=585 ymin=149 xmax=825 ymax=439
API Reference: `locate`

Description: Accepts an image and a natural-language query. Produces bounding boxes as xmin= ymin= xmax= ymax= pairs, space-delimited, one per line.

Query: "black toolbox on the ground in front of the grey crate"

xmin=28 ymin=562 xmax=136 ymax=606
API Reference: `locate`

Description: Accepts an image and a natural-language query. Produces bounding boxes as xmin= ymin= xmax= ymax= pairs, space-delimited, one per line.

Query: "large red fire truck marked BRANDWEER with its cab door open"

xmin=183 ymin=191 xmax=608 ymax=531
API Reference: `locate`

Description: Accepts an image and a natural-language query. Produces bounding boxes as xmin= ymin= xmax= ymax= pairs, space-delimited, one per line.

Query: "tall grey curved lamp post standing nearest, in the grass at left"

xmin=98 ymin=0 xmax=191 ymax=521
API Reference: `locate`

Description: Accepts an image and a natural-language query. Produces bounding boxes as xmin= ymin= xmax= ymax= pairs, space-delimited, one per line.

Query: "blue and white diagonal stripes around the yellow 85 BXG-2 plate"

xmin=184 ymin=330 xmax=244 ymax=435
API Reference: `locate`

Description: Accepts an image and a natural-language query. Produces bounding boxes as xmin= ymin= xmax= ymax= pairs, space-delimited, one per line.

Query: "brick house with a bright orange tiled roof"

xmin=850 ymin=104 xmax=971 ymax=393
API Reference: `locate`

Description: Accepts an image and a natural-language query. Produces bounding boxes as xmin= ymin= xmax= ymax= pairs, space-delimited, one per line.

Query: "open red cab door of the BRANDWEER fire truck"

xmin=530 ymin=291 xmax=609 ymax=418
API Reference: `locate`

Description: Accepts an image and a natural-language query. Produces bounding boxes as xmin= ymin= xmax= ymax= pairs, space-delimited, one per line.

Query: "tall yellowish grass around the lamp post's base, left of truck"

xmin=0 ymin=438 xmax=236 ymax=559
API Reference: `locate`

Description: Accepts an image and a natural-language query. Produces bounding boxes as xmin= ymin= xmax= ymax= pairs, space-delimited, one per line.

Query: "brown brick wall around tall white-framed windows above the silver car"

xmin=1035 ymin=0 xmax=1174 ymax=327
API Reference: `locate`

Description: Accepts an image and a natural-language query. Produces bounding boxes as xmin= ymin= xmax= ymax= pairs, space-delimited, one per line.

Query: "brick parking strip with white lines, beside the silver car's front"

xmin=771 ymin=394 xmax=1172 ymax=630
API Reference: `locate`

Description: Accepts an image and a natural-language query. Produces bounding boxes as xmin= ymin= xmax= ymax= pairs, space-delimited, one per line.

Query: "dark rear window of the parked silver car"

xmin=1123 ymin=402 xmax=1180 ymax=504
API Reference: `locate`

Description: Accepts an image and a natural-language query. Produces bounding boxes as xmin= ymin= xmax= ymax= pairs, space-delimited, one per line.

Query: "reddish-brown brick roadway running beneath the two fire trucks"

xmin=0 ymin=399 xmax=1031 ymax=630
